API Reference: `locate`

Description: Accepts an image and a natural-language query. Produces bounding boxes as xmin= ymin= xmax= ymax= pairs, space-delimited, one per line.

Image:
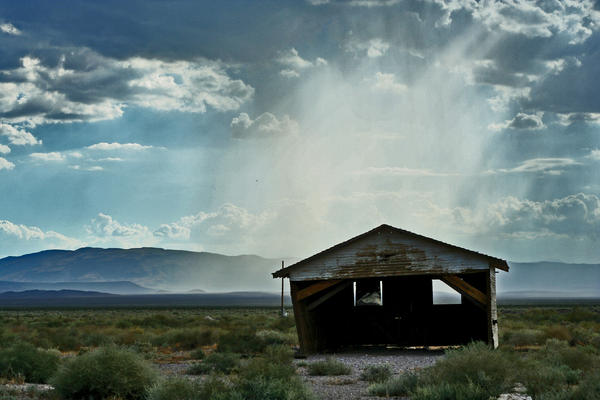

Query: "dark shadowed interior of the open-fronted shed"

xmin=292 ymin=272 xmax=488 ymax=352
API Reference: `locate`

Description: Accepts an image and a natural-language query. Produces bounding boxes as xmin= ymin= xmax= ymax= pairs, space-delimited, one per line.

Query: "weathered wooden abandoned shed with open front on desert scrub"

xmin=273 ymin=225 xmax=508 ymax=353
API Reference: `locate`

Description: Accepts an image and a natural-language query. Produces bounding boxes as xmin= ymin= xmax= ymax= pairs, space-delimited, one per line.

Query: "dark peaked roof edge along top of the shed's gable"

xmin=272 ymin=224 xmax=509 ymax=278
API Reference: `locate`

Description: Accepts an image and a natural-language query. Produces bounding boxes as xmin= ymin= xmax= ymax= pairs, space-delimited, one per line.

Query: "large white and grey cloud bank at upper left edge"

xmin=0 ymin=49 xmax=254 ymax=125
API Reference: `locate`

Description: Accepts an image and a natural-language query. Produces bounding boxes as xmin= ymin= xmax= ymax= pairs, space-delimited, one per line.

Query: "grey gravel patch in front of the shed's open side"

xmin=296 ymin=350 xmax=443 ymax=400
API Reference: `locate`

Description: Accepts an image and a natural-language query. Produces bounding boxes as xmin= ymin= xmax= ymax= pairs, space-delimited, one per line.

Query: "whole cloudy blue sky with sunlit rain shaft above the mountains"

xmin=0 ymin=0 xmax=600 ymax=262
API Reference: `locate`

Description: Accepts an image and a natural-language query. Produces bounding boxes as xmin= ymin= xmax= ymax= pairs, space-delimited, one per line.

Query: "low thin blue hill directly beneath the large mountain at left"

xmin=0 ymin=281 xmax=156 ymax=294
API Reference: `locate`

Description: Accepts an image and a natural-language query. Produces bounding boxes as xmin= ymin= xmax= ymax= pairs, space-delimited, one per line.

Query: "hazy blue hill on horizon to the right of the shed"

xmin=496 ymin=261 xmax=600 ymax=298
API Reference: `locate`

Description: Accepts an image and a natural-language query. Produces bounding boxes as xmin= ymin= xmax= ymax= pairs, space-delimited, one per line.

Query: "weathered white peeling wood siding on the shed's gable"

xmin=289 ymin=230 xmax=490 ymax=281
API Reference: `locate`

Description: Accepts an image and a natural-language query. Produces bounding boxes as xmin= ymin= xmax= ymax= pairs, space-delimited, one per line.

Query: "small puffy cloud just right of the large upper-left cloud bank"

xmin=230 ymin=112 xmax=298 ymax=139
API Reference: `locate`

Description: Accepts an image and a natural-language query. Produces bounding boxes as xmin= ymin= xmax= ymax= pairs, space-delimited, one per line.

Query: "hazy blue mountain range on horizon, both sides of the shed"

xmin=0 ymin=247 xmax=600 ymax=298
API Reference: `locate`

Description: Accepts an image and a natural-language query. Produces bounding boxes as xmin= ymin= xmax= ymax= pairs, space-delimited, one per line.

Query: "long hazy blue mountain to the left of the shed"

xmin=0 ymin=247 xmax=288 ymax=292
